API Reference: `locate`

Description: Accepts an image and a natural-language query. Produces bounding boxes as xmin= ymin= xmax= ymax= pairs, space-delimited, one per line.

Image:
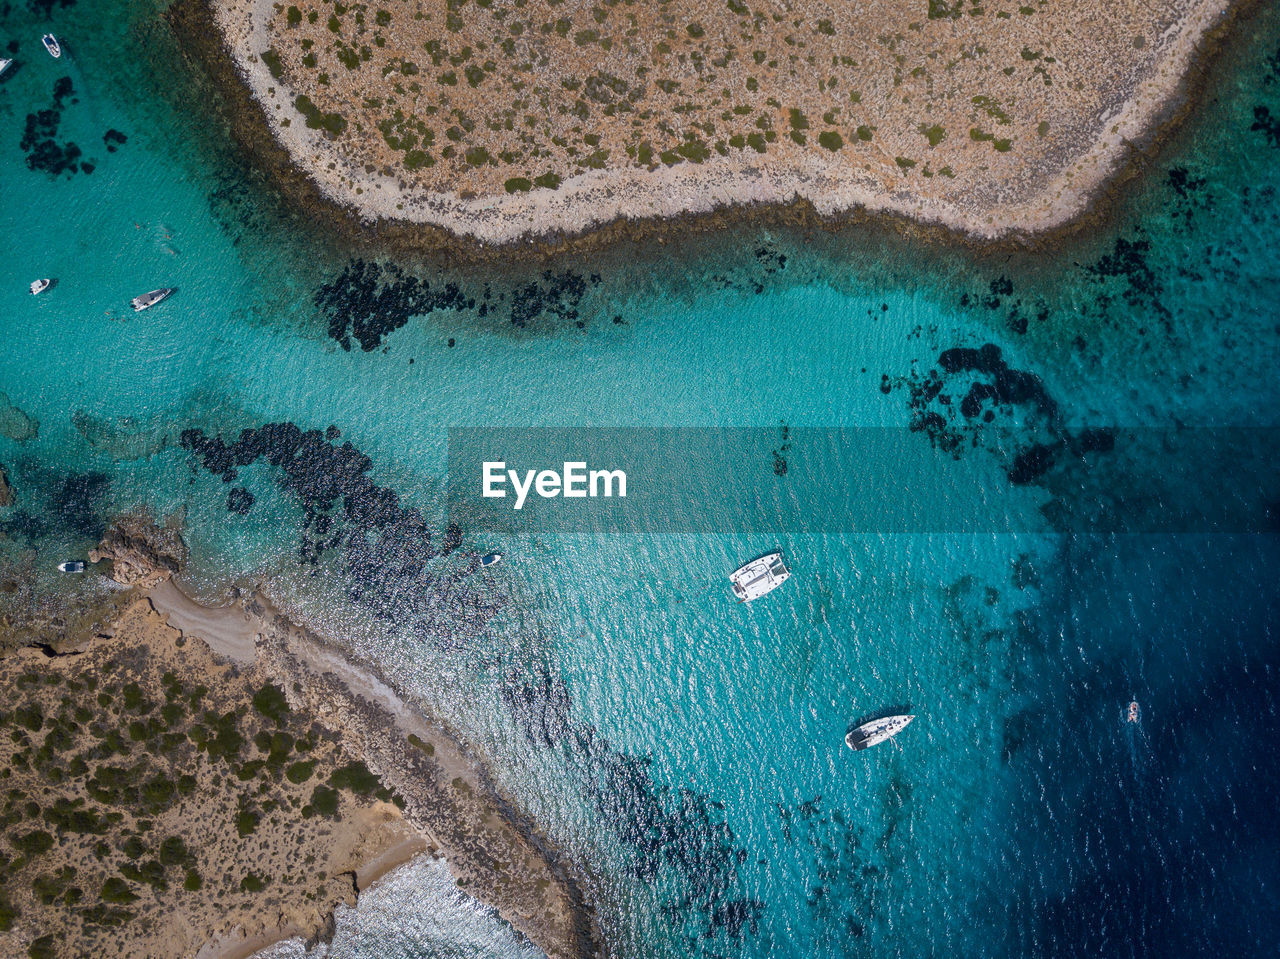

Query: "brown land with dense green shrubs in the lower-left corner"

xmin=0 ymin=599 xmax=425 ymax=956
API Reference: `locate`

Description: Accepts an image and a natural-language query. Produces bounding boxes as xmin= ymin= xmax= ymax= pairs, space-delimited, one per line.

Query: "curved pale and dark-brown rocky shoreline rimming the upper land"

xmin=166 ymin=0 xmax=1252 ymax=261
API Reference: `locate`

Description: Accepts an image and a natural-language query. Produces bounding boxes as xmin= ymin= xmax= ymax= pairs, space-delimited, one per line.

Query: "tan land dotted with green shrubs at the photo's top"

xmin=212 ymin=0 xmax=1226 ymax=239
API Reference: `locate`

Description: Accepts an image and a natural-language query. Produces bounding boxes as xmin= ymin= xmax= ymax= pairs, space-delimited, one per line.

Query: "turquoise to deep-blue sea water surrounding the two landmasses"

xmin=0 ymin=0 xmax=1280 ymax=956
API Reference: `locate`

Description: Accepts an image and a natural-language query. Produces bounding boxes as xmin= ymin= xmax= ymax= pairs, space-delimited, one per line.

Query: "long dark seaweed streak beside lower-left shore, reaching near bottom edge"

xmin=502 ymin=666 xmax=764 ymax=954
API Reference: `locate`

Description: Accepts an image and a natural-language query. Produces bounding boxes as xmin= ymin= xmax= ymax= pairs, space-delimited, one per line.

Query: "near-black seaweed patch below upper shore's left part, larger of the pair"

xmin=315 ymin=260 xmax=475 ymax=352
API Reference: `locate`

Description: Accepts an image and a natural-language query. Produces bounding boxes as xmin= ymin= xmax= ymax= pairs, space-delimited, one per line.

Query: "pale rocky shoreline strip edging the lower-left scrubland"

xmin=147 ymin=581 xmax=599 ymax=959
